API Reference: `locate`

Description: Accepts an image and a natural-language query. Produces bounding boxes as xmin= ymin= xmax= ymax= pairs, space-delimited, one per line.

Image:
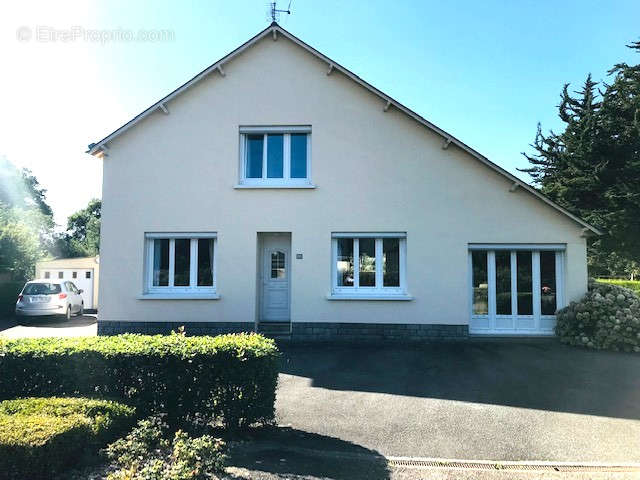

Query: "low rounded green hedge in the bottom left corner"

xmin=0 ymin=398 xmax=136 ymax=480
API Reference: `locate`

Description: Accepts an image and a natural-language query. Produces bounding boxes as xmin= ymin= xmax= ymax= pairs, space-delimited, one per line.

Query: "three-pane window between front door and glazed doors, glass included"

xmin=332 ymin=233 xmax=406 ymax=297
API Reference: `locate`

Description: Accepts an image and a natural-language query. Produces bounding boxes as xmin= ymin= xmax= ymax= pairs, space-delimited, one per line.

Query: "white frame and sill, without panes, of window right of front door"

xmin=329 ymin=232 xmax=412 ymax=300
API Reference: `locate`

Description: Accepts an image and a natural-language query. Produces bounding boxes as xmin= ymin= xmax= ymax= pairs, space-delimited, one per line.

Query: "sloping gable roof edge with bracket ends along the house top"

xmin=86 ymin=22 xmax=602 ymax=235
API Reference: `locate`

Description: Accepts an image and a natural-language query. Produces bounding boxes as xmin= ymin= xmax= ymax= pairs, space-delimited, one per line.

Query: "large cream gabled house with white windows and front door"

xmin=88 ymin=23 xmax=599 ymax=340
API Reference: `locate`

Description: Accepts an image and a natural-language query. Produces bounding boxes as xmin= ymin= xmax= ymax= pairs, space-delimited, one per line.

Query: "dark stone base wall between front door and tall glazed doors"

xmin=291 ymin=322 xmax=469 ymax=342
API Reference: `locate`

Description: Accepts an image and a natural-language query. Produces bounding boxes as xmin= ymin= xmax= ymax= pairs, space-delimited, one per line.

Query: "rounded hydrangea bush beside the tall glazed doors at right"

xmin=556 ymin=282 xmax=640 ymax=352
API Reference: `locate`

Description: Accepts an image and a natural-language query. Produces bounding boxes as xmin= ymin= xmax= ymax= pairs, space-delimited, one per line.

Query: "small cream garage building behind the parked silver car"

xmin=36 ymin=256 xmax=100 ymax=310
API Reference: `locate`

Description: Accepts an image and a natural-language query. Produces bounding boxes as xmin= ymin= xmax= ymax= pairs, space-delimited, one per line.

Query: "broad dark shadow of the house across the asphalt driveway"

xmin=280 ymin=339 xmax=640 ymax=420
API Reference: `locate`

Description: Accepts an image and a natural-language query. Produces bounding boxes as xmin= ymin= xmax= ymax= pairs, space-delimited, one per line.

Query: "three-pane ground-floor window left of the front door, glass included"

xmin=145 ymin=233 xmax=216 ymax=294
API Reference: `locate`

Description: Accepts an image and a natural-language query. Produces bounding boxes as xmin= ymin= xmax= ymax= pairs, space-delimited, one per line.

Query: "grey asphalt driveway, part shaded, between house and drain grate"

xmin=274 ymin=340 xmax=640 ymax=462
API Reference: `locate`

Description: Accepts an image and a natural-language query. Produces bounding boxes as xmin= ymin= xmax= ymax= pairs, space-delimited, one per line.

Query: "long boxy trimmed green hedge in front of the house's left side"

xmin=0 ymin=334 xmax=278 ymax=427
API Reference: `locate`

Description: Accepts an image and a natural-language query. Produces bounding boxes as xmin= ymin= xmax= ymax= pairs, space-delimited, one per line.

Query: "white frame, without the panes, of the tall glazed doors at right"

xmin=468 ymin=244 xmax=566 ymax=335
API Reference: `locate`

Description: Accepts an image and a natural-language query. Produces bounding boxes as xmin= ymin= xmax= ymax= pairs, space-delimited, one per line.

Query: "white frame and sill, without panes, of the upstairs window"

xmin=239 ymin=126 xmax=314 ymax=188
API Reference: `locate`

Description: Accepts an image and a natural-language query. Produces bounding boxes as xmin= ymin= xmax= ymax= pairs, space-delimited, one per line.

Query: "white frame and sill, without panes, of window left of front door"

xmin=138 ymin=232 xmax=219 ymax=299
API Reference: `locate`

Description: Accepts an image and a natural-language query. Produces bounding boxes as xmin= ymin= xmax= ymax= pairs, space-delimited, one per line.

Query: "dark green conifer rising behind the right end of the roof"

xmin=522 ymin=42 xmax=640 ymax=276
